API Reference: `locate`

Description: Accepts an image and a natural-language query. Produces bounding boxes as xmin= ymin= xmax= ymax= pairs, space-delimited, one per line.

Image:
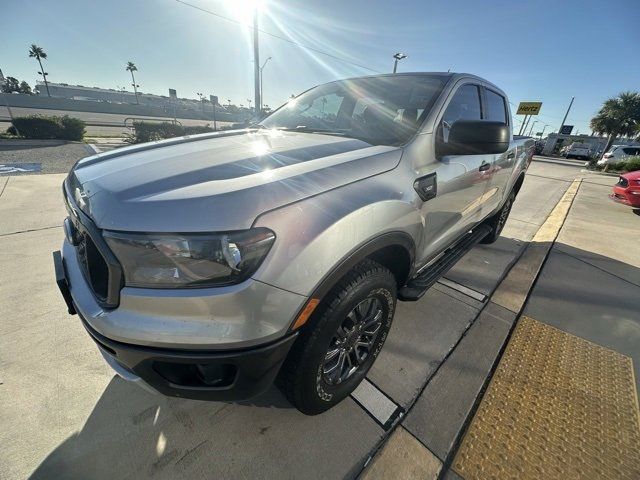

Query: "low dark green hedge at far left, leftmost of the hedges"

xmin=13 ymin=115 xmax=85 ymax=141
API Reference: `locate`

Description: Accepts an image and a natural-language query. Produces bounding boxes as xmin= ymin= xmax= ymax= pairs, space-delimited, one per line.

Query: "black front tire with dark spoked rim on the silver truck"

xmin=277 ymin=260 xmax=397 ymax=415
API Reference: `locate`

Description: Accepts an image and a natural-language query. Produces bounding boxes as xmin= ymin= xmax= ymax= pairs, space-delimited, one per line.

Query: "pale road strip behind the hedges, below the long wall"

xmin=0 ymin=105 xmax=230 ymax=136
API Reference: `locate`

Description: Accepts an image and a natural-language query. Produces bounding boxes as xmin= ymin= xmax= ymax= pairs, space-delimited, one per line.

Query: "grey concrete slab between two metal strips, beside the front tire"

xmin=368 ymin=288 xmax=479 ymax=407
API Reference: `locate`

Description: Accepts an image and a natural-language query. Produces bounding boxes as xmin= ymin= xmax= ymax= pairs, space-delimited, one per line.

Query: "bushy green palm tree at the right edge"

xmin=590 ymin=92 xmax=640 ymax=156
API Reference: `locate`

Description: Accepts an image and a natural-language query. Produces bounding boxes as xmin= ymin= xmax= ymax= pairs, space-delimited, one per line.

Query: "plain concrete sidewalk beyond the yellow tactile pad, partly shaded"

xmin=524 ymin=181 xmax=640 ymax=389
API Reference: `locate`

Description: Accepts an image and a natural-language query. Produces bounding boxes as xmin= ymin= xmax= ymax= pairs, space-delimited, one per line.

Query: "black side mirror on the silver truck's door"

xmin=440 ymin=120 xmax=510 ymax=155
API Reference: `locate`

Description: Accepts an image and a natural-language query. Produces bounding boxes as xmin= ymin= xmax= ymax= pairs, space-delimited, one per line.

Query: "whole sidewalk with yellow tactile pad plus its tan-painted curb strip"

xmin=362 ymin=176 xmax=640 ymax=480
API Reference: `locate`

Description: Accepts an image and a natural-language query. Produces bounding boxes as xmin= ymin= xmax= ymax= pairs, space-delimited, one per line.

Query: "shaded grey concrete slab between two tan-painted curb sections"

xmin=403 ymin=311 xmax=511 ymax=461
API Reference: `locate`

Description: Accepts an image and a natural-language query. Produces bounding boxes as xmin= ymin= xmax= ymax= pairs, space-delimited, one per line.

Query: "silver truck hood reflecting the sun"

xmin=66 ymin=130 xmax=402 ymax=232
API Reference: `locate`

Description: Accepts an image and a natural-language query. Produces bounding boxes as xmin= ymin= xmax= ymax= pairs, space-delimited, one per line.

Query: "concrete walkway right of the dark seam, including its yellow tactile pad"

xmin=452 ymin=179 xmax=640 ymax=480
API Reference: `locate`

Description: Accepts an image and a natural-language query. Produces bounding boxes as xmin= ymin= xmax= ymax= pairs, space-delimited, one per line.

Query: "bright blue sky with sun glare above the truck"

xmin=0 ymin=0 xmax=640 ymax=133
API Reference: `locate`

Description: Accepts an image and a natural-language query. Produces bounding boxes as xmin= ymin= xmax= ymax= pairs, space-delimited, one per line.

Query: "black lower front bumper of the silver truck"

xmin=53 ymin=252 xmax=297 ymax=400
